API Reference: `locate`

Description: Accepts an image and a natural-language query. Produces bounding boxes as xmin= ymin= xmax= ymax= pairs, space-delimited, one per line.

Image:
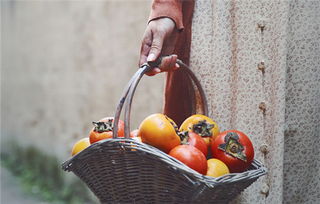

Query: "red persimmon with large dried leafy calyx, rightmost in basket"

xmin=211 ymin=130 xmax=254 ymax=173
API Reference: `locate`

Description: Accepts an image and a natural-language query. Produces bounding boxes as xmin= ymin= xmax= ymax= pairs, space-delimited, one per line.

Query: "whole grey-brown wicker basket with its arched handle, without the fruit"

xmin=62 ymin=60 xmax=266 ymax=204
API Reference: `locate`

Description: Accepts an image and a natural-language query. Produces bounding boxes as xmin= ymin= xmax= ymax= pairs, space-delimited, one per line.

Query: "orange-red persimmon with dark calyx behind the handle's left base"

xmin=89 ymin=117 xmax=124 ymax=144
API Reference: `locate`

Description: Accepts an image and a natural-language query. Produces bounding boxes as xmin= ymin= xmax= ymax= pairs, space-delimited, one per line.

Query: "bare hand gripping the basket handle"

xmin=139 ymin=18 xmax=179 ymax=76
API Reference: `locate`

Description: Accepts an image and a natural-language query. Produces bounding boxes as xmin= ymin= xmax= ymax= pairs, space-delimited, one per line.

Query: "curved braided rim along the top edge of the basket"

xmin=61 ymin=138 xmax=267 ymax=186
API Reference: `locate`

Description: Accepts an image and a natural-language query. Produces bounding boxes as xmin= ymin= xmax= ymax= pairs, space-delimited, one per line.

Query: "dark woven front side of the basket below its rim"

xmin=72 ymin=143 xmax=202 ymax=203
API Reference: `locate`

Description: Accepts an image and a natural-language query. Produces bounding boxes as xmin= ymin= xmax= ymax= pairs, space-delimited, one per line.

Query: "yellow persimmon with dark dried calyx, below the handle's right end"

xmin=179 ymin=114 xmax=220 ymax=146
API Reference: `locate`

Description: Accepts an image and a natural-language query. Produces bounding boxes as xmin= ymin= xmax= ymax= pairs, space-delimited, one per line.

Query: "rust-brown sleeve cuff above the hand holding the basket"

xmin=148 ymin=0 xmax=184 ymax=30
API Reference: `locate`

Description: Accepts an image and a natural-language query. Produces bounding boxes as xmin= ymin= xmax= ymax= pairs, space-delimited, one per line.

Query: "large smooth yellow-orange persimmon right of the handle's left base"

xmin=139 ymin=113 xmax=180 ymax=153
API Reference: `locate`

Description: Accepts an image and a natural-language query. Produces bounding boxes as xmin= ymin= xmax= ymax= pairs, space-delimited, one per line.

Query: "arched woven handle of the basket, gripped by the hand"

xmin=113 ymin=58 xmax=208 ymax=138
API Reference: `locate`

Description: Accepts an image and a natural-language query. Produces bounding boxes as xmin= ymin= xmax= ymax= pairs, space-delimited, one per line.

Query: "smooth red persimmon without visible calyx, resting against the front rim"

xmin=169 ymin=145 xmax=207 ymax=174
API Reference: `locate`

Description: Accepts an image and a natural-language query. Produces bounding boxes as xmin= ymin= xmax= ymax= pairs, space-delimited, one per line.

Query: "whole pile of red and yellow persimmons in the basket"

xmin=72 ymin=113 xmax=254 ymax=177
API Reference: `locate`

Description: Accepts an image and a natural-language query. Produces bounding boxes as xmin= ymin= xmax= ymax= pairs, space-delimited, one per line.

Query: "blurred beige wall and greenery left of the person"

xmin=1 ymin=0 xmax=164 ymax=204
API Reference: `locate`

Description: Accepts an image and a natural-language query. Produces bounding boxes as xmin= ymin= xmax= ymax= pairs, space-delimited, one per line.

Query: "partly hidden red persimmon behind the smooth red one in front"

xmin=179 ymin=131 xmax=208 ymax=156
